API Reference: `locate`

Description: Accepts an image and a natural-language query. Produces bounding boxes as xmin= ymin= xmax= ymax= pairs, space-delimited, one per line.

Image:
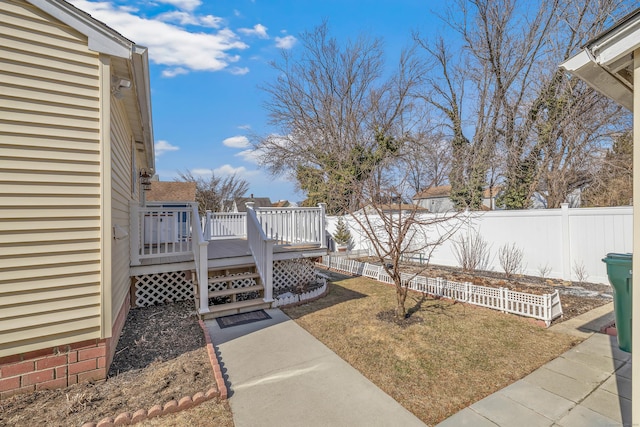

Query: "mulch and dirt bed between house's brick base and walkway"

xmin=0 ymin=302 xmax=233 ymax=426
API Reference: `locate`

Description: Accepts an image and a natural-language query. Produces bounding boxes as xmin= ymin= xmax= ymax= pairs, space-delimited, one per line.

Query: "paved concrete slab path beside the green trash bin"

xmin=438 ymin=303 xmax=631 ymax=427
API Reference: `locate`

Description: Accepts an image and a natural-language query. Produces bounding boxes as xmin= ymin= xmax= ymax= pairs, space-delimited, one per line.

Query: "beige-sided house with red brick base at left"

xmin=0 ymin=0 xmax=154 ymax=397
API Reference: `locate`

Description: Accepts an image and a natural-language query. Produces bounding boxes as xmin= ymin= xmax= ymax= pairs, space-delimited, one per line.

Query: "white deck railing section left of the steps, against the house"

xmin=131 ymin=203 xmax=199 ymax=265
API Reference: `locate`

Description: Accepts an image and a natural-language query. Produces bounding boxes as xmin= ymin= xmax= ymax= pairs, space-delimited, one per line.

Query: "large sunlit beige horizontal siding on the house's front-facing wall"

xmin=0 ymin=0 xmax=101 ymax=357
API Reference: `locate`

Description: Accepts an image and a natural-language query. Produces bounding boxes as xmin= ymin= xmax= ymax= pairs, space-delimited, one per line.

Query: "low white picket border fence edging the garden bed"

xmin=318 ymin=256 xmax=562 ymax=326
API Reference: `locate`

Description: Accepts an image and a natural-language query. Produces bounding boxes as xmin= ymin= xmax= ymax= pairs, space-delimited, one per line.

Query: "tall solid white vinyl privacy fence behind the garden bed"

xmin=327 ymin=206 xmax=633 ymax=284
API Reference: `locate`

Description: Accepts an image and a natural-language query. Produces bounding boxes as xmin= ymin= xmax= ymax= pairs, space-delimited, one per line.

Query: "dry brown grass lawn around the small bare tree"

xmin=284 ymin=275 xmax=579 ymax=425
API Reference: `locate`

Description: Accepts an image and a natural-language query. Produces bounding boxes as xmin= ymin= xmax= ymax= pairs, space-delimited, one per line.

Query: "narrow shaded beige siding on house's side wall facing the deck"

xmin=111 ymin=99 xmax=133 ymax=326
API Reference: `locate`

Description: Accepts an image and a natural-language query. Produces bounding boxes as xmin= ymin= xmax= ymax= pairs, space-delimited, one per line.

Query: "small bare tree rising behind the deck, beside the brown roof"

xmin=175 ymin=170 xmax=249 ymax=215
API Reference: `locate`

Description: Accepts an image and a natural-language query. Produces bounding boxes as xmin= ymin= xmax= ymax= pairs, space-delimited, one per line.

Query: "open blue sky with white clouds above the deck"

xmin=69 ymin=0 xmax=446 ymax=201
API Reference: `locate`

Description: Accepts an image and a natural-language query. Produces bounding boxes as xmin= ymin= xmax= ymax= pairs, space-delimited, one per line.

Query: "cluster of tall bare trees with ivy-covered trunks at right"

xmin=416 ymin=0 xmax=630 ymax=208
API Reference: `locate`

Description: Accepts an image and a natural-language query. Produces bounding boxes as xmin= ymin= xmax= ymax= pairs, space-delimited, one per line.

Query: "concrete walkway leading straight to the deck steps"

xmin=205 ymin=309 xmax=424 ymax=427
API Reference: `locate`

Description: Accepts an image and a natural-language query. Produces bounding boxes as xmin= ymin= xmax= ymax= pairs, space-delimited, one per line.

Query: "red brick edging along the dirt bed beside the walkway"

xmin=82 ymin=320 xmax=228 ymax=427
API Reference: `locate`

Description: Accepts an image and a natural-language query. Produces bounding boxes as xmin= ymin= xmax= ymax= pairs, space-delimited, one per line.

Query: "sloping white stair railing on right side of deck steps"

xmin=247 ymin=203 xmax=275 ymax=302
